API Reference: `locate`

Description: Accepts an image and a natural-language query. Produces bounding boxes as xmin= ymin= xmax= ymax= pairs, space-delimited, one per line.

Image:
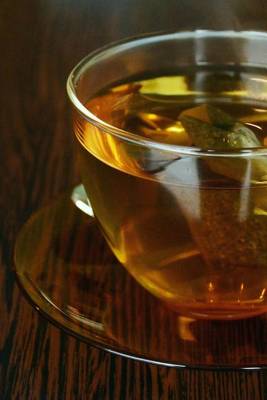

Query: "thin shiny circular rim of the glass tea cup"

xmin=66 ymin=29 xmax=267 ymax=158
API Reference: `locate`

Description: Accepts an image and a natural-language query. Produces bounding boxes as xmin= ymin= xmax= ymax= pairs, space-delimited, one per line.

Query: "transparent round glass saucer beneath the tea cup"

xmin=15 ymin=193 xmax=267 ymax=369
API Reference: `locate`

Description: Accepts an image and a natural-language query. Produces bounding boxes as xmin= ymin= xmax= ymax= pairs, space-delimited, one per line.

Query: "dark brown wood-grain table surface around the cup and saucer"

xmin=0 ymin=0 xmax=267 ymax=400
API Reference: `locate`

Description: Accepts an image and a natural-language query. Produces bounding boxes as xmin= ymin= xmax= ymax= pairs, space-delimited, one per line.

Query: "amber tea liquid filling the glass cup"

xmin=74 ymin=69 xmax=267 ymax=319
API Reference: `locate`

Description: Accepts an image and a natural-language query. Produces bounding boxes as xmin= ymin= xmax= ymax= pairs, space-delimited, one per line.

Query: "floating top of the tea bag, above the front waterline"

xmin=180 ymin=105 xmax=267 ymax=183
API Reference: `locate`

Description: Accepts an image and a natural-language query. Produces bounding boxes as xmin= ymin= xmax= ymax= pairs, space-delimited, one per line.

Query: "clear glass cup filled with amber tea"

xmin=67 ymin=31 xmax=267 ymax=319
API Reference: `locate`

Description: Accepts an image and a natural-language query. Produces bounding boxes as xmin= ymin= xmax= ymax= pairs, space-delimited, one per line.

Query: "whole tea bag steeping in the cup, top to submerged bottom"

xmin=177 ymin=105 xmax=267 ymax=284
